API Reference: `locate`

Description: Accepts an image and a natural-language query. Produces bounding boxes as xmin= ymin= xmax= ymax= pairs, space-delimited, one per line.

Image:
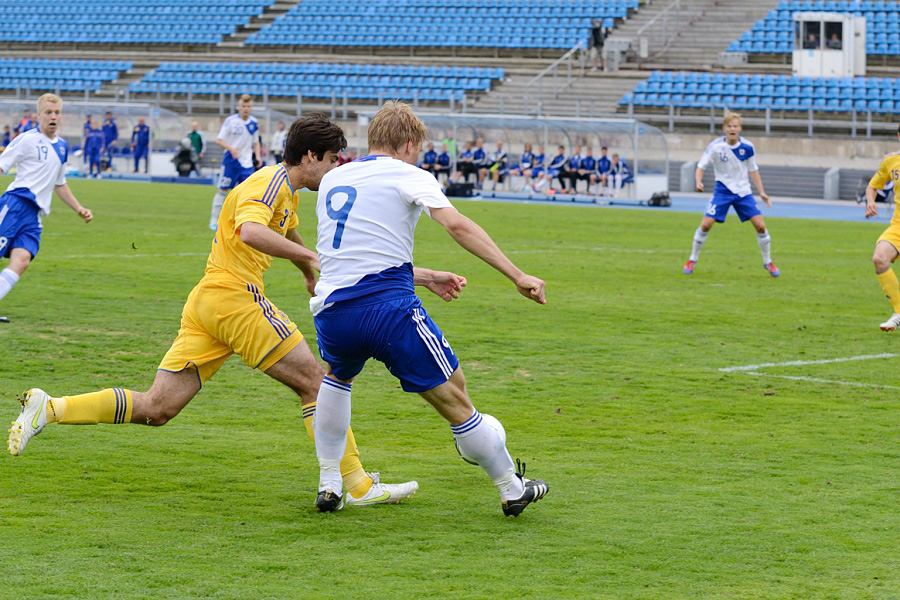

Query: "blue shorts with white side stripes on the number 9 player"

xmin=313 ymin=291 xmax=459 ymax=392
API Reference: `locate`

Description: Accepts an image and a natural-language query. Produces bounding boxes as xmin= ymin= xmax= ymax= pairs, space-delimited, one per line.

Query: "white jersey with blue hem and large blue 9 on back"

xmin=309 ymin=155 xmax=453 ymax=314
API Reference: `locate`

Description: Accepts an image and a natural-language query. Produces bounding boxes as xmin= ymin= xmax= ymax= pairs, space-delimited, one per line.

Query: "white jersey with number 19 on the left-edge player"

xmin=0 ymin=129 xmax=69 ymax=215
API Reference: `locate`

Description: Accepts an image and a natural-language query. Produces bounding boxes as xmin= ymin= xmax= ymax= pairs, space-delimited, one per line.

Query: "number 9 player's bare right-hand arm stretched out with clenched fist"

xmin=430 ymin=208 xmax=547 ymax=304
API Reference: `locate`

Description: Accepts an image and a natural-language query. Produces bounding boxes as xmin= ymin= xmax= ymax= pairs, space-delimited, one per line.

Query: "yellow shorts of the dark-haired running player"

xmin=159 ymin=277 xmax=303 ymax=384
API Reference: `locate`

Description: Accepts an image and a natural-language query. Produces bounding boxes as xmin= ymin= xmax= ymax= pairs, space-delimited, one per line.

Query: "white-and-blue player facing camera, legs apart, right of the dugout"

xmin=684 ymin=112 xmax=781 ymax=277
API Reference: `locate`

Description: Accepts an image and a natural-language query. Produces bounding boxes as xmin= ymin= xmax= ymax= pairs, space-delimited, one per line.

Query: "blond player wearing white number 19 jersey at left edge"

xmin=0 ymin=94 xmax=94 ymax=322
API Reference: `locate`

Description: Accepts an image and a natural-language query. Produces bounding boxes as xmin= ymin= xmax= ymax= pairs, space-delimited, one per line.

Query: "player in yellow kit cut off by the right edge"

xmin=866 ymin=127 xmax=900 ymax=331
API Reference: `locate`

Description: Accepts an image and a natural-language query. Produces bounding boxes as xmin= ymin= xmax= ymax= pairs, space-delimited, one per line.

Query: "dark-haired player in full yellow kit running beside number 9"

xmin=9 ymin=115 xmax=418 ymax=505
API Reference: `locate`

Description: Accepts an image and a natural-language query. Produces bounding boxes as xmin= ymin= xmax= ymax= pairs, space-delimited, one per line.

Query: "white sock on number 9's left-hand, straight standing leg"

xmin=313 ymin=375 xmax=352 ymax=493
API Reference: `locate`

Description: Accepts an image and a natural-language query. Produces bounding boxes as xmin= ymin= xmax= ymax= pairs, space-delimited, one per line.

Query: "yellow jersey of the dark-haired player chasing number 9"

xmin=206 ymin=165 xmax=299 ymax=290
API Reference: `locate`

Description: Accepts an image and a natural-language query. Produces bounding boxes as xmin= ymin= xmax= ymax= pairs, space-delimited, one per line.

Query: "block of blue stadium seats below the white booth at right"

xmin=619 ymin=72 xmax=900 ymax=113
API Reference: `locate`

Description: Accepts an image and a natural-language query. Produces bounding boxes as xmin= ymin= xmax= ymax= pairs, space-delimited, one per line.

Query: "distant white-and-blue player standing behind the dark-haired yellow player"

xmin=209 ymin=94 xmax=260 ymax=231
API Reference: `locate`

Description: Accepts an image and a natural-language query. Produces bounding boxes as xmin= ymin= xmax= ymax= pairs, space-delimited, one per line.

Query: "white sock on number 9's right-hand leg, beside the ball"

xmin=454 ymin=410 xmax=524 ymax=500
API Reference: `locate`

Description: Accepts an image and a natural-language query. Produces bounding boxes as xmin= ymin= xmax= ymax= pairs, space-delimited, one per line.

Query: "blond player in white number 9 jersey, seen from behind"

xmin=310 ymin=101 xmax=548 ymax=516
